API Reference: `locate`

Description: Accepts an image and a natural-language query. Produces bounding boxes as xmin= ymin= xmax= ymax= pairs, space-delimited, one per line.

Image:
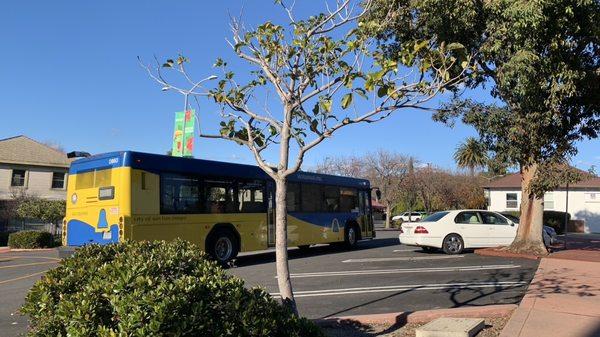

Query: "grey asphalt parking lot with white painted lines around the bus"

xmin=0 ymin=231 xmax=538 ymax=337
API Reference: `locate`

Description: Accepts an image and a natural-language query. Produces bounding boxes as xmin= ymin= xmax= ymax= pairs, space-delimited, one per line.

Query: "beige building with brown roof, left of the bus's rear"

xmin=0 ymin=135 xmax=71 ymax=200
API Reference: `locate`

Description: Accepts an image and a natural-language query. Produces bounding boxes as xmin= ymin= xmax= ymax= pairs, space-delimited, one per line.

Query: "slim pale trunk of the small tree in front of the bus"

xmin=275 ymin=178 xmax=298 ymax=316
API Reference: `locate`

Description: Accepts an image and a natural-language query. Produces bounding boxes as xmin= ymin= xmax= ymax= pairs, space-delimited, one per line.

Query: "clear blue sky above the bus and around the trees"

xmin=0 ymin=0 xmax=600 ymax=169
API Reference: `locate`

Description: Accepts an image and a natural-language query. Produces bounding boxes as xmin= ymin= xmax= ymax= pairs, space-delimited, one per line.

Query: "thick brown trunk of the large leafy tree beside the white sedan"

xmin=507 ymin=164 xmax=548 ymax=255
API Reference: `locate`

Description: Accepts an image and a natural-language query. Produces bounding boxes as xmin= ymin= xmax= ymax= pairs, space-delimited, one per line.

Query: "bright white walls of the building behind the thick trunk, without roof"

xmin=488 ymin=190 xmax=600 ymax=233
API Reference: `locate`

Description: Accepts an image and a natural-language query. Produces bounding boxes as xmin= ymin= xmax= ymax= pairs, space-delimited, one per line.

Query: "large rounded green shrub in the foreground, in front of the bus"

xmin=21 ymin=240 xmax=323 ymax=336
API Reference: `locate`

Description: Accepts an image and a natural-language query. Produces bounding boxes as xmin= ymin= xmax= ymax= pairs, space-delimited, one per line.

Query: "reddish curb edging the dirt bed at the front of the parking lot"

xmin=314 ymin=304 xmax=517 ymax=326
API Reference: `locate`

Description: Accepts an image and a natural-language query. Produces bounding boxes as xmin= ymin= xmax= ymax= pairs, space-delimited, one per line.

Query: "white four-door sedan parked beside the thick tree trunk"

xmin=399 ymin=210 xmax=518 ymax=254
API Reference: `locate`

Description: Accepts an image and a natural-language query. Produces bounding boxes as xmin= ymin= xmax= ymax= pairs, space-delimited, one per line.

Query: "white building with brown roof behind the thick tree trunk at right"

xmin=483 ymin=173 xmax=600 ymax=233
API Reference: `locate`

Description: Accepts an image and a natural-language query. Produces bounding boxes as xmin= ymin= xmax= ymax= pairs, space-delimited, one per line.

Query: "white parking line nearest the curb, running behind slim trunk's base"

xmin=271 ymin=281 xmax=528 ymax=298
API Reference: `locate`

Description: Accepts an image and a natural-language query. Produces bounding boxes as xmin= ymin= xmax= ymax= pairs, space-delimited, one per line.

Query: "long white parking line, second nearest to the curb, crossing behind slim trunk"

xmin=282 ymin=264 xmax=521 ymax=278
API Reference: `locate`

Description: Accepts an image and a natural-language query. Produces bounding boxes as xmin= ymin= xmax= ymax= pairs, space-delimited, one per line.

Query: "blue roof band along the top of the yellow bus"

xmin=69 ymin=151 xmax=370 ymax=188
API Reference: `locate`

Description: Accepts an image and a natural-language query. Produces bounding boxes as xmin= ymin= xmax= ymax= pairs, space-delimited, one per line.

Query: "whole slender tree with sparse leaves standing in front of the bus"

xmin=140 ymin=0 xmax=472 ymax=312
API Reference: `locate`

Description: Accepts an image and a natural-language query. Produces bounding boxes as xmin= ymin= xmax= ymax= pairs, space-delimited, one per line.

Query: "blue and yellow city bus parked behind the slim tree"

xmin=62 ymin=151 xmax=375 ymax=262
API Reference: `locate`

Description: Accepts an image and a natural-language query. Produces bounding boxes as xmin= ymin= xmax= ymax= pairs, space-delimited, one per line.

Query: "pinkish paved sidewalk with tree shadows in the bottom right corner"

xmin=500 ymin=238 xmax=600 ymax=337
